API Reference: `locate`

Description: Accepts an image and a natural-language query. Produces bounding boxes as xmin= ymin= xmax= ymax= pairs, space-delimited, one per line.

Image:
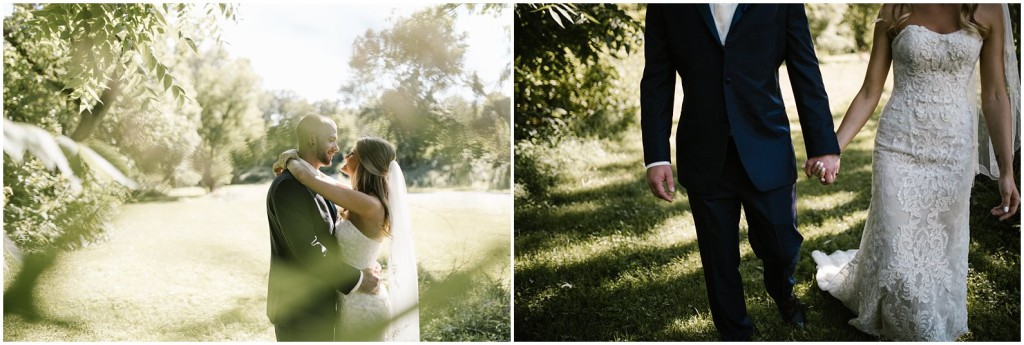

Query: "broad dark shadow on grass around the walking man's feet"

xmin=515 ymin=224 xmax=873 ymax=341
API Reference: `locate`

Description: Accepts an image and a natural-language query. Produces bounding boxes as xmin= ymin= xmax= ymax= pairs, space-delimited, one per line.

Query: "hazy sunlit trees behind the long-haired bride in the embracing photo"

xmin=342 ymin=5 xmax=511 ymax=188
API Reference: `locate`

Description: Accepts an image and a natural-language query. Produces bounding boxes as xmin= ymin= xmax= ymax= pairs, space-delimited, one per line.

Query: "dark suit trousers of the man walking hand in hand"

xmin=688 ymin=138 xmax=804 ymax=340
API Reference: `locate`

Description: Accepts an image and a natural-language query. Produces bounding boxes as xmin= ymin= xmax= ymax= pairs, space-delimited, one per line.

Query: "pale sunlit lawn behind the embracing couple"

xmin=3 ymin=184 xmax=511 ymax=341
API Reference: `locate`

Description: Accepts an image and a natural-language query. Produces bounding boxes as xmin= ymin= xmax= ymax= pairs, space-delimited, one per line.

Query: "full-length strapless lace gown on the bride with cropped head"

xmin=812 ymin=25 xmax=982 ymax=341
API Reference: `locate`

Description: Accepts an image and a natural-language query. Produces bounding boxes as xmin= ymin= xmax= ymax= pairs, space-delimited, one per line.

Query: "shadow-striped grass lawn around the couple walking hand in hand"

xmin=513 ymin=57 xmax=1021 ymax=341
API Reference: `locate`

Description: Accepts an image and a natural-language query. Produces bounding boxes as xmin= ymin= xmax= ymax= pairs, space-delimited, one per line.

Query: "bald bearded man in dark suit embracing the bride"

xmin=266 ymin=115 xmax=379 ymax=341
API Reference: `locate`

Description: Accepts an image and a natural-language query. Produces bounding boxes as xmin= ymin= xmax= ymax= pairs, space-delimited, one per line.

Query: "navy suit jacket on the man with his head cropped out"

xmin=640 ymin=4 xmax=840 ymax=192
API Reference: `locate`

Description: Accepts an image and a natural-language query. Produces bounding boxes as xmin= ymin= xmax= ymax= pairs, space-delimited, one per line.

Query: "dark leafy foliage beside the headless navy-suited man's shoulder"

xmin=514 ymin=4 xmax=642 ymax=142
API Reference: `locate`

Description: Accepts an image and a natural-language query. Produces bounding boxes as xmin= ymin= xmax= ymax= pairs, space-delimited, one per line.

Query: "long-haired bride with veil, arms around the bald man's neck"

xmin=274 ymin=137 xmax=420 ymax=341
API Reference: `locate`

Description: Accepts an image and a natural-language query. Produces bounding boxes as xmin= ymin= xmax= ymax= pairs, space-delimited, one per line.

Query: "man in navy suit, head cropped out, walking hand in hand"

xmin=640 ymin=4 xmax=840 ymax=340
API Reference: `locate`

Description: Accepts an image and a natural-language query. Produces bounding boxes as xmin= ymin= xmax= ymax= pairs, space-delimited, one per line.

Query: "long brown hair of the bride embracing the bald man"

xmin=352 ymin=136 xmax=396 ymax=235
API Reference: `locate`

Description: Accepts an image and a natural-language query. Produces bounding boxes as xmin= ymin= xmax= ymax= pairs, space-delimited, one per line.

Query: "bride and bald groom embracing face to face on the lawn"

xmin=266 ymin=115 xmax=420 ymax=341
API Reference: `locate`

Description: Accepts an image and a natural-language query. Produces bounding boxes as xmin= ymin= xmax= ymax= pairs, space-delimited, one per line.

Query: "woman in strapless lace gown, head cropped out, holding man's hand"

xmin=806 ymin=4 xmax=1020 ymax=341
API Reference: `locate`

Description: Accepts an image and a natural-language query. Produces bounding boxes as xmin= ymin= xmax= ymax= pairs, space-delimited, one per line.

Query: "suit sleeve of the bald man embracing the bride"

xmin=272 ymin=179 xmax=362 ymax=294
